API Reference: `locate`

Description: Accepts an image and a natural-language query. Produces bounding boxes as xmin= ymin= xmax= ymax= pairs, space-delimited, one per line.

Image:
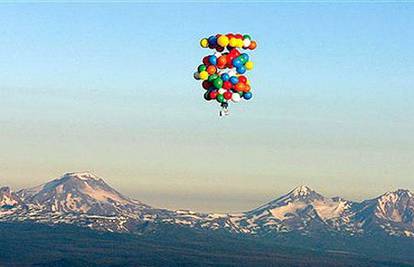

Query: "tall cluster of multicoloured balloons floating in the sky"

xmin=194 ymin=33 xmax=257 ymax=114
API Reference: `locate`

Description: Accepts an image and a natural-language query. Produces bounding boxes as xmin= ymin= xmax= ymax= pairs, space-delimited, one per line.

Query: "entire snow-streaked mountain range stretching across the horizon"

xmin=0 ymin=172 xmax=414 ymax=240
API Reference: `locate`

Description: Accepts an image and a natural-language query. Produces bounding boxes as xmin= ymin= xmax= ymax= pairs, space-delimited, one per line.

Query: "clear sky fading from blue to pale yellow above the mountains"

xmin=0 ymin=2 xmax=414 ymax=212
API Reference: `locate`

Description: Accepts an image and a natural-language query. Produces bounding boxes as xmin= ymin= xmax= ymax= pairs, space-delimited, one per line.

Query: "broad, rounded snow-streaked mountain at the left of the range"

xmin=0 ymin=172 xmax=167 ymax=232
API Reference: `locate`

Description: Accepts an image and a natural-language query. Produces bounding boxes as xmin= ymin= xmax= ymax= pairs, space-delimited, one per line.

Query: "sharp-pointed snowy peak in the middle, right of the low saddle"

xmin=226 ymin=186 xmax=353 ymax=237
